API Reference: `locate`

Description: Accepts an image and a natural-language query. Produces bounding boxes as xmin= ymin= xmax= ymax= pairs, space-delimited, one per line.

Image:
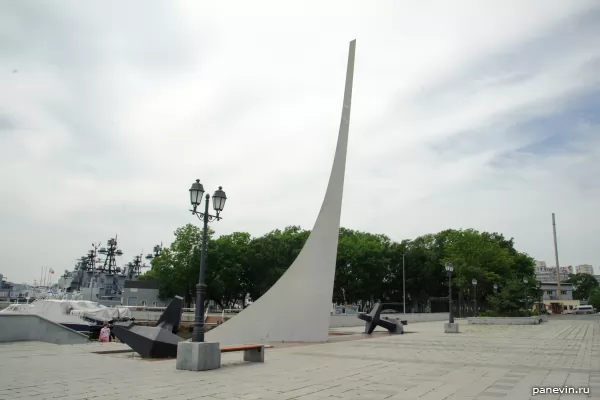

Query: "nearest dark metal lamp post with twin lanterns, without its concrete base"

xmin=190 ymin=179 xmax=227 ymax=342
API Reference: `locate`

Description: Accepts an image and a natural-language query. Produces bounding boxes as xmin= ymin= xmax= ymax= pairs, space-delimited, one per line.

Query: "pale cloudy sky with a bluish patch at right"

xmin=0 ymin=0 xmax=600 ymax=283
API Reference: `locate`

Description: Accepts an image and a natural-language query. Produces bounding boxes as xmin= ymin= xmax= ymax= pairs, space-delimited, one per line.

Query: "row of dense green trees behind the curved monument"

xmin=141 ymin=224 xmax=537 ymax=309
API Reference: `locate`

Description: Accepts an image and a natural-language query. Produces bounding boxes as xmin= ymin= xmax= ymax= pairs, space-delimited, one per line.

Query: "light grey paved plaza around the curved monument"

xmin=0 ymin=319 xmax=600 ymax=400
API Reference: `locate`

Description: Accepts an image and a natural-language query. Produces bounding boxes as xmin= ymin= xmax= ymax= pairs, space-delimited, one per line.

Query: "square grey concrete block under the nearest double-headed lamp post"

xmin=176 ymin=341 xmax=221 ymax=371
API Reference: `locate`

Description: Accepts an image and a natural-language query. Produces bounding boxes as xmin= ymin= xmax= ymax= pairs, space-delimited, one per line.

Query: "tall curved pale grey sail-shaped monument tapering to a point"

xmin=206 ymin=40 xmax=356 ymax=345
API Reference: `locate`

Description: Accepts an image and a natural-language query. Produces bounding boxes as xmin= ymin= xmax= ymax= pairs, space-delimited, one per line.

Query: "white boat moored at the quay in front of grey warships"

xmin=1 ymin=299 xmax=132 ymax=333
